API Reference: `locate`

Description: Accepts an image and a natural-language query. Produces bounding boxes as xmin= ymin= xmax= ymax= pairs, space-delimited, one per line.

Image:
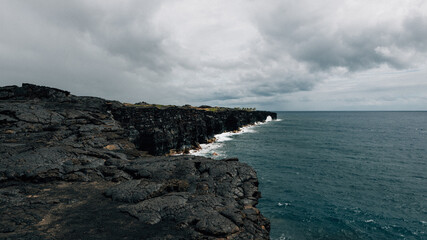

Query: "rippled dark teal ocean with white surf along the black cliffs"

xmin=193 ymin=112 xmax=427 ymax=240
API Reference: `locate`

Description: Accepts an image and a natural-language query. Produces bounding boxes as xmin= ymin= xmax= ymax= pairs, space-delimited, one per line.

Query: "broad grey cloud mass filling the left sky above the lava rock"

xmin=0 ymin=1 xmax=177 ymax=100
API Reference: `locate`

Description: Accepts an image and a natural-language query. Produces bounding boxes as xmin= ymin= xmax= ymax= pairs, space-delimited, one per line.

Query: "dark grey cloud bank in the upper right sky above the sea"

xmin=258 ymin=1 xmax=427 ymax=71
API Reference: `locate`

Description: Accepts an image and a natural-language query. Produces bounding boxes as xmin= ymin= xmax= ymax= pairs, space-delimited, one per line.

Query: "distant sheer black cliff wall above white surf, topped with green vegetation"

xmin=113 ymin=107 xmax=277 ymax=155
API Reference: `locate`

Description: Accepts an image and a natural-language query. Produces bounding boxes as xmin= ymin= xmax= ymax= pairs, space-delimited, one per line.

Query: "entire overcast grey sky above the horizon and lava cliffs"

xmin=0 ymin=0 xmax=427 ymax=110
